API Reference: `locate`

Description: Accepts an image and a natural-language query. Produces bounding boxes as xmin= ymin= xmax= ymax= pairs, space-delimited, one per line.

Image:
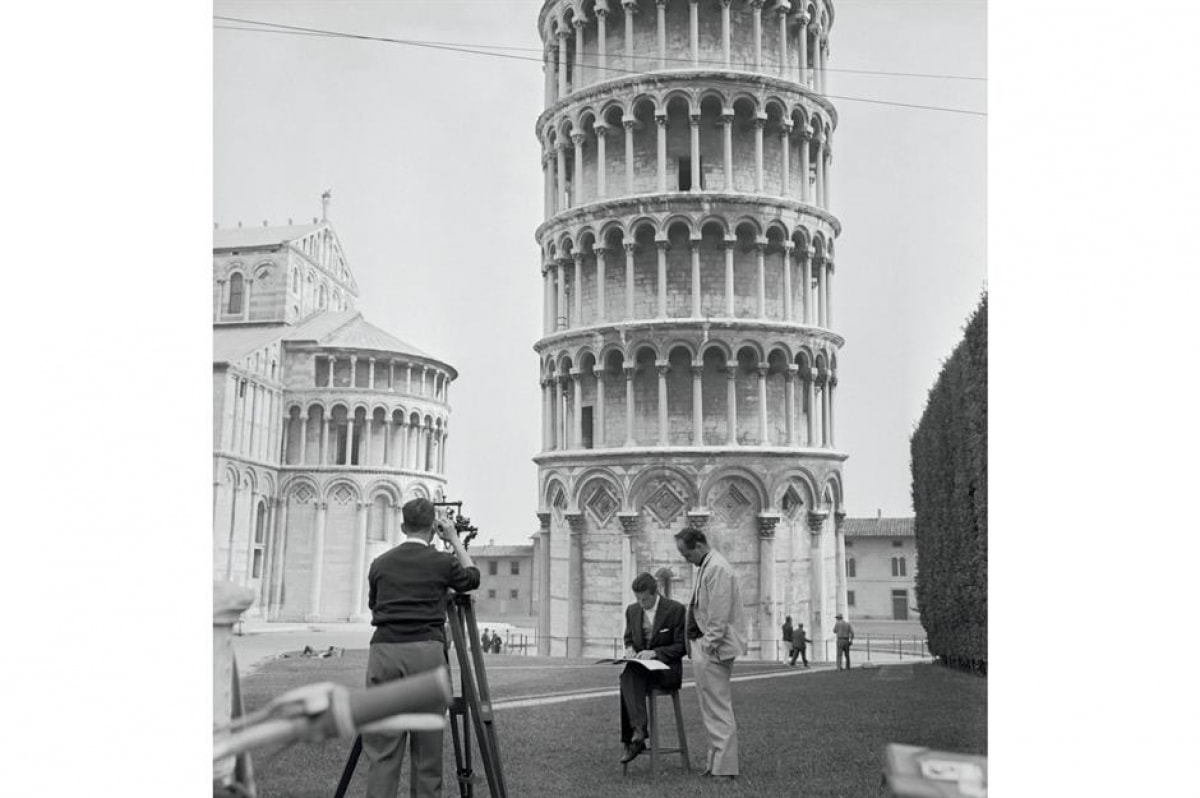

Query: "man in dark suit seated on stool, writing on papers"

xmin=620 ymin=574 xmax=686 ymax=764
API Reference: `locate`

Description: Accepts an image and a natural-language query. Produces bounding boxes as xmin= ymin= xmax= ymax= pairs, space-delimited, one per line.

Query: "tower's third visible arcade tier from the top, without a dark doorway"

xmin=540 ymin=210 xmax=839 ymax=336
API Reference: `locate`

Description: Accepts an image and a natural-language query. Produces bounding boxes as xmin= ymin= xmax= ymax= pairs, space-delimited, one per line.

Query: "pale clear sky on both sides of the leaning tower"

xmin=212 ymin=0 xmax=988 ymax=544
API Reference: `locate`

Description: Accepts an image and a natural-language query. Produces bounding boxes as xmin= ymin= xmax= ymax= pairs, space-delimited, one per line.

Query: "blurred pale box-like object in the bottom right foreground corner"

xmin=880 ymin=743 xmax=988 ymax=798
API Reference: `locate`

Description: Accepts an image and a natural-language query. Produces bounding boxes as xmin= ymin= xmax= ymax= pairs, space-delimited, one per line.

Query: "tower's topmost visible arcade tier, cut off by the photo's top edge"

xmin=539 ymin=0 xmax=834 ymax=106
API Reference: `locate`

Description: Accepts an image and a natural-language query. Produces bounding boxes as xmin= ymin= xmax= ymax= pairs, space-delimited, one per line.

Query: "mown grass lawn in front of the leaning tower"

xmin=242 ymin=652 xmax=988 ymax=798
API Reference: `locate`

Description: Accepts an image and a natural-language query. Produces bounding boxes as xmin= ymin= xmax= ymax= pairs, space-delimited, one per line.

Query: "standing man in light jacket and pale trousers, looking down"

xmin=674 ymin=527 xmax=746 ymax=781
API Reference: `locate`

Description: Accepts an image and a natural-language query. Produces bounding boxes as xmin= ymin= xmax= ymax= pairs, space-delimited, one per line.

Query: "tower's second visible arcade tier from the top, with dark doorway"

xmin=536 ymin=81 xmax=838 ymax=218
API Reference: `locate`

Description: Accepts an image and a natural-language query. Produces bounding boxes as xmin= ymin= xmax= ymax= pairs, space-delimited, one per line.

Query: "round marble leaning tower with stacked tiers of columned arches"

xmin=534 ymin=0 xmax=846 ymax=659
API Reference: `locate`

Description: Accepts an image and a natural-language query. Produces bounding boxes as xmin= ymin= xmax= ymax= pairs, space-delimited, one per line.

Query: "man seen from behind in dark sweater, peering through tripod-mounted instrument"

xmin=362 ymin=498 xmax=479 ymax=798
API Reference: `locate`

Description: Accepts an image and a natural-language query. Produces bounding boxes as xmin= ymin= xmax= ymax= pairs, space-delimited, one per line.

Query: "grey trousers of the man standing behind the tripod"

xmin=362 ymin=641 xmax=446 ymax=798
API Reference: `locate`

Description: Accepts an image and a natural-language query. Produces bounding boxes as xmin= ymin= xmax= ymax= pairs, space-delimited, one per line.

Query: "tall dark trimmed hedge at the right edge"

xmin=911 ymin=294 xmax=988 ymax=672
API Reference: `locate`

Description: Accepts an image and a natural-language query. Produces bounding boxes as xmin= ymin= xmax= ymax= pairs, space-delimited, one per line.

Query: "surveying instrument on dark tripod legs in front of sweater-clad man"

xmin=334 ymin=502 xmax=509 ymax=798
